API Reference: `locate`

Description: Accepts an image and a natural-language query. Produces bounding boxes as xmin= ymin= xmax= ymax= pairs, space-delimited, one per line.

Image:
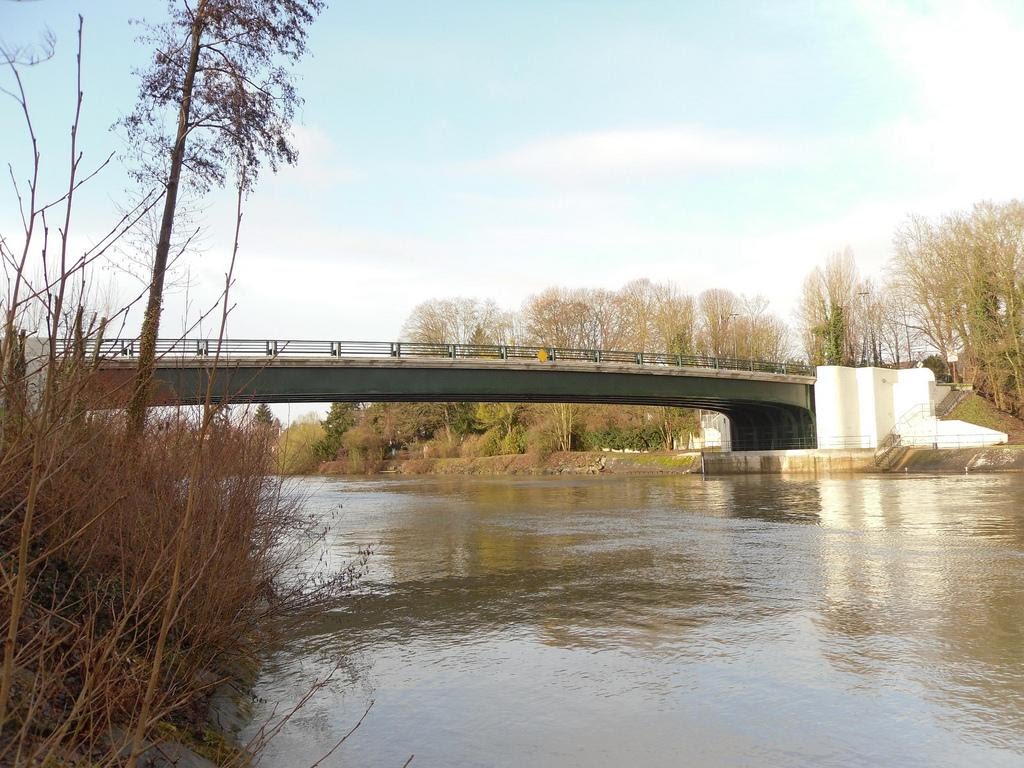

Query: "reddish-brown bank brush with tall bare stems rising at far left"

xmin=0 ymin=18 xmax=355 ymax=766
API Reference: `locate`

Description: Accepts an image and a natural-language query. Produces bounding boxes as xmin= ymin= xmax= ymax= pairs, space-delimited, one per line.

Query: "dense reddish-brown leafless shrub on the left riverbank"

xmin=0 ymin=391 xmax=356 ymax=764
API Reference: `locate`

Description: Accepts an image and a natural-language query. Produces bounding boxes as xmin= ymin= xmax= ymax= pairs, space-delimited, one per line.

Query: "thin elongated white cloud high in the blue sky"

xmin=476 ymin=127 xmax=794 ymax=185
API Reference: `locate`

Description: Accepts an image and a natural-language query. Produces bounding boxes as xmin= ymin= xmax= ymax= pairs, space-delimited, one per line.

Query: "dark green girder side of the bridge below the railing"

xmin=104 ymin=359 xmax=815 ymax=451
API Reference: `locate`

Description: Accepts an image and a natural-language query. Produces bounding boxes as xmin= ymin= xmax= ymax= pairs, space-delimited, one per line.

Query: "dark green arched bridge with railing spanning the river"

xmin=95 ymin=339 xmax=816 ymax=451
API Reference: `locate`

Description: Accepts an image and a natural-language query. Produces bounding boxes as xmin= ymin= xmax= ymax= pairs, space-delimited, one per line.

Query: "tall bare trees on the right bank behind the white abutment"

xmin=797 ymin=200 xmax=1024 ymax=416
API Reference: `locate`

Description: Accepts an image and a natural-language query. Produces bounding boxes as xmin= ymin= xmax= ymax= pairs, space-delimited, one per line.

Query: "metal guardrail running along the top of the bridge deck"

xmin=86 ymin=339 xmax=814 ymax=376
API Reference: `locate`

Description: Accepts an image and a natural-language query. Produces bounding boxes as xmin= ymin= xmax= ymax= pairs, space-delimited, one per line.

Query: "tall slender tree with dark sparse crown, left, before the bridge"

xmin=122 ymin=0 xmax=324 ymax=432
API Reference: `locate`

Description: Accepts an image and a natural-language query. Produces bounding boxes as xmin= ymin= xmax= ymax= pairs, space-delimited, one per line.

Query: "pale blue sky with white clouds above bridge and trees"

xmin=6 ymin=0 xmax=1024 ymax=340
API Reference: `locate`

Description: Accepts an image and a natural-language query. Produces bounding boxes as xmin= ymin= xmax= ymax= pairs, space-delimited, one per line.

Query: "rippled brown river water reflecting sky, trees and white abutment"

xmin=245 ymin=476 xmax=1024 ymax=767
